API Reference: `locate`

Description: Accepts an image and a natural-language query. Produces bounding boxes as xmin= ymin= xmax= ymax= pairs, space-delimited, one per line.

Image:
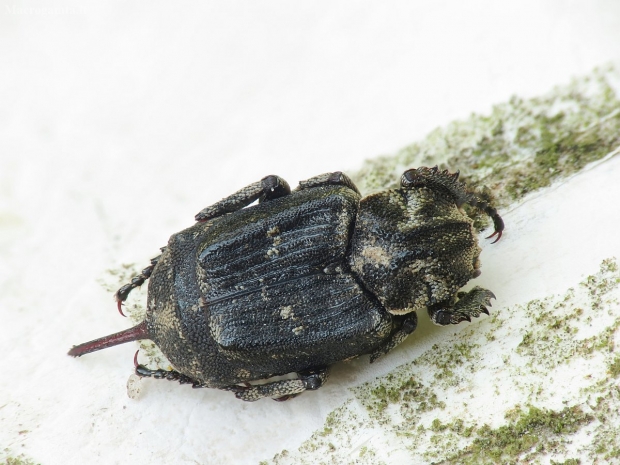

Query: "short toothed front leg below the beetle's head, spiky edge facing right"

xmin=428 ymin=286 xmax=495 ymax=326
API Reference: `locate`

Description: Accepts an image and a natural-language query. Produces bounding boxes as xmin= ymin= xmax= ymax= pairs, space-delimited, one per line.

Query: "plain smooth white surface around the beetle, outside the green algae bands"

xmin=0 ymin=1 xmax=620 ymax=464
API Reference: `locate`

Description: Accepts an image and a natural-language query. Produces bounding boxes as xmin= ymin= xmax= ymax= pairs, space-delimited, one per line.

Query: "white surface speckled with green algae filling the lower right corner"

xmin=264 ymin=259 xmax=620 ymax=465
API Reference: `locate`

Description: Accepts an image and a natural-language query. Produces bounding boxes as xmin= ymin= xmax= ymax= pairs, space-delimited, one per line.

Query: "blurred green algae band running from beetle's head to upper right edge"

xmin=352 ymin=65 xmax=620 ymax=227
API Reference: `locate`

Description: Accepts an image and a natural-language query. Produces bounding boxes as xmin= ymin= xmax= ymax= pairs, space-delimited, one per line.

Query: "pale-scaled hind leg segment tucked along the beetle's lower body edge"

xmin=223 ymin=367 xmax=328 ymax=402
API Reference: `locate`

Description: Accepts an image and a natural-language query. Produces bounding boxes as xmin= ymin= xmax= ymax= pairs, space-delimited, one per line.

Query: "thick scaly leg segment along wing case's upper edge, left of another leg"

xmin=195 ymin=175 xmax=291 ymax=221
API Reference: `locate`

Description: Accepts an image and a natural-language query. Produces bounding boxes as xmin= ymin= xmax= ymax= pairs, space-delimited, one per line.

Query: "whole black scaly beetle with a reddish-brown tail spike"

xmin=69 ymin=167 xmax=504 ymax=401
